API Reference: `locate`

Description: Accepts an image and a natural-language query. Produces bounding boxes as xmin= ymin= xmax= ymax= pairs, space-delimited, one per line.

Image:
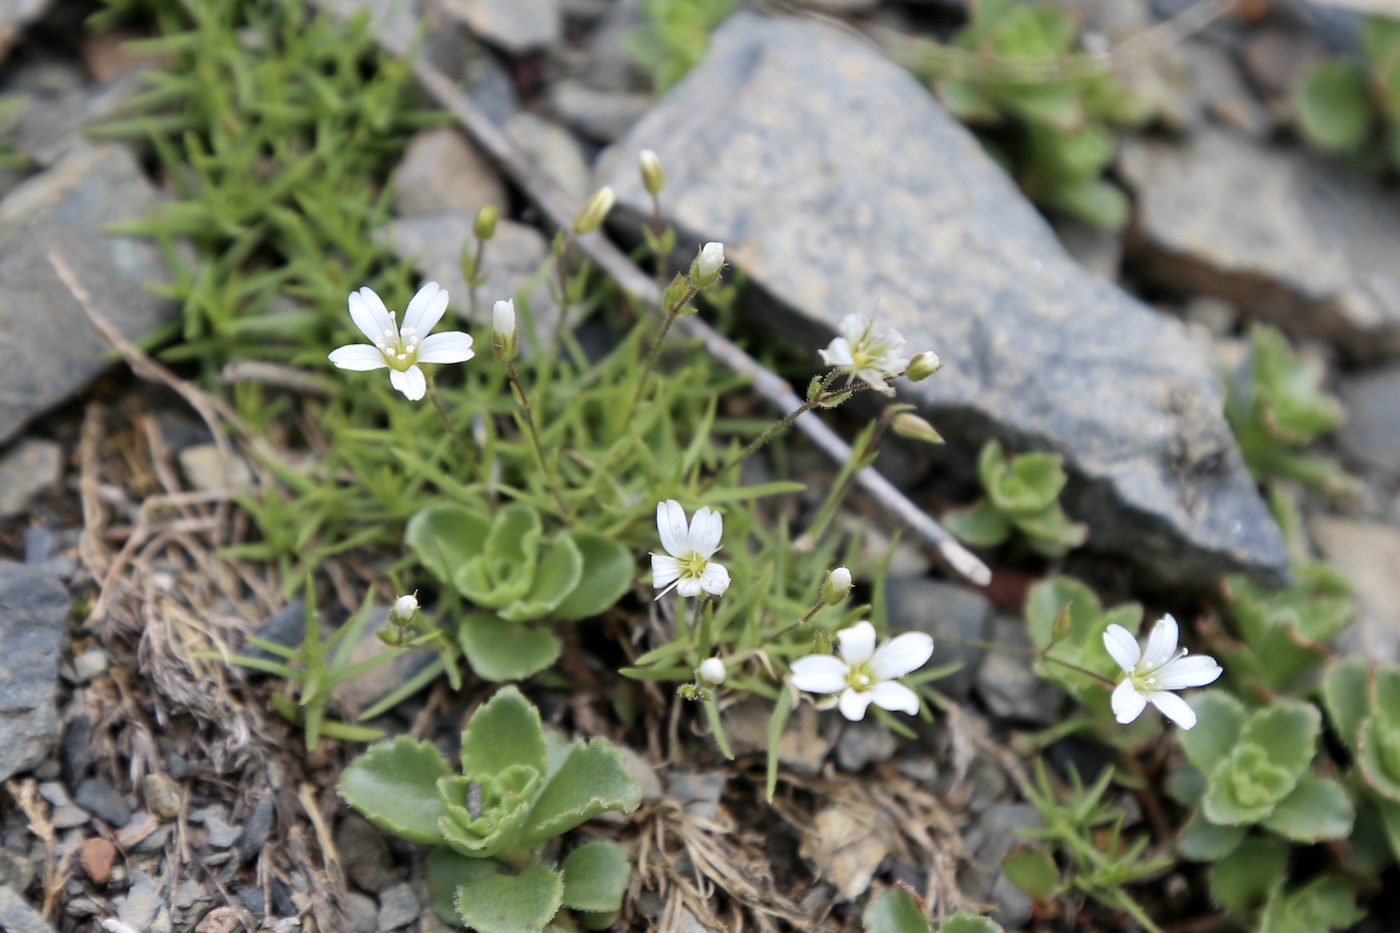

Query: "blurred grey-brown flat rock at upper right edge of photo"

xmin=1119 ymin=127 xmax=1400 ymax=359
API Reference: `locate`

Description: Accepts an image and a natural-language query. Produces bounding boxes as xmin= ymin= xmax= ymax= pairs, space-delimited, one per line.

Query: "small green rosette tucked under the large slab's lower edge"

xmin=942 ymin=440 xmax=1089 ymax=558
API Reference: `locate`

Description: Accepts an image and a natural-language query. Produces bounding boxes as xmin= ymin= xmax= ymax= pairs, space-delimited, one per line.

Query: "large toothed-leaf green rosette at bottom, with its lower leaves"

xmin=339 ymin=686 xmax=641 ymax=933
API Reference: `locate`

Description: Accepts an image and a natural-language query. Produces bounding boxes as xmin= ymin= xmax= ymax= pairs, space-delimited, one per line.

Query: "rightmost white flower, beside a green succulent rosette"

xmin=1103 ymin=615 xmax=1224 ymax=728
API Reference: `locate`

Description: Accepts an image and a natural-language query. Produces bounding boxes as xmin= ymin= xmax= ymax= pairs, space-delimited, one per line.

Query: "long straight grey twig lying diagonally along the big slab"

xmin=381 ymin=39 xmax=991 ymax=586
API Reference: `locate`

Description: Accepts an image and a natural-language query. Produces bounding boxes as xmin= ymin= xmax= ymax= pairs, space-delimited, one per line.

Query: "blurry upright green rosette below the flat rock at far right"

xmin=1225 ymin=324 xmax=1358 ymax=496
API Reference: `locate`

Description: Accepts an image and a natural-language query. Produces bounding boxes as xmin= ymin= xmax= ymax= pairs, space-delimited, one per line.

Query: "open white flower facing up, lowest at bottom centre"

xmin=790 ymin=622 xmax=934 ymax=721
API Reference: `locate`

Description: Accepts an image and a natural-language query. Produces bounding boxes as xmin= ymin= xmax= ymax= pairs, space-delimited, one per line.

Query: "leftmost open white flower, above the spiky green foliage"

xmin=330 ymin=282 xmax=476 ymax=401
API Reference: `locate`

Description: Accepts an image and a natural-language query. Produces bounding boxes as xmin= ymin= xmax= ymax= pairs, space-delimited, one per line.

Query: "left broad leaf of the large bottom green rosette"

xmin=337 ymin=735 xmax=452 ymax=845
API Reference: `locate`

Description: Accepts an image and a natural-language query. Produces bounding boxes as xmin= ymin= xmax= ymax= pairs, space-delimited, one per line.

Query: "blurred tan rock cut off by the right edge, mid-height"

xmin=1309 ymin=516 xmax=1400 ymax=661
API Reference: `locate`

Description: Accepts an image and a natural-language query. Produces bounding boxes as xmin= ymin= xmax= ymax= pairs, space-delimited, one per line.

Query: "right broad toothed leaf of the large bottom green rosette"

xmin=524 ymin=738 xmax=641 ymax=846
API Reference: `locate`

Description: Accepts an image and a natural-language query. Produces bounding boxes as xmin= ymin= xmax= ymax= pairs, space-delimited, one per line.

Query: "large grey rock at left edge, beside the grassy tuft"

xmin=0 ymin=146 xmax=176 ymax=443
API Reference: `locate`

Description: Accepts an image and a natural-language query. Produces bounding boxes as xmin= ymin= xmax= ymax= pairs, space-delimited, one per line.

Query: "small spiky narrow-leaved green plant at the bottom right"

xmin=1001 ymin=762 xmax=1164 ymax=932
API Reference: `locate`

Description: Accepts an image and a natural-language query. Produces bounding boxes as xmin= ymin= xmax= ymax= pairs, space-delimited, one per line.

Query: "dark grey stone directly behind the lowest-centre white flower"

xmin=885 ymin=577 xmax=993 ymax=699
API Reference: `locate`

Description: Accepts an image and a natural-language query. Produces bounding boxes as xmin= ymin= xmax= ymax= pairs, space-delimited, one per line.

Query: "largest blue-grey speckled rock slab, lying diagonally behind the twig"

xmin=599 ymin=14 xmax=1287 ymax=587
